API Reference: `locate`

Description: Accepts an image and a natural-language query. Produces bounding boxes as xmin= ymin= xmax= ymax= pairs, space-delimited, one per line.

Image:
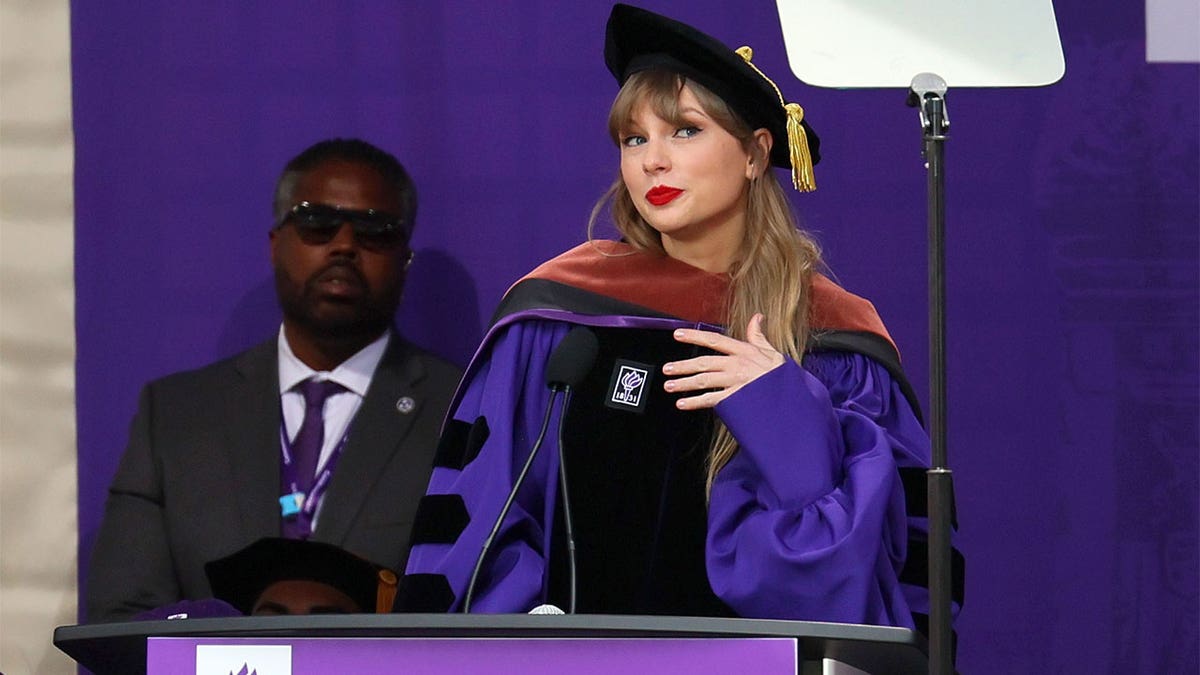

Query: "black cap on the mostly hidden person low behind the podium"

xmin=204 ymin=537 xmax=396 ymax=615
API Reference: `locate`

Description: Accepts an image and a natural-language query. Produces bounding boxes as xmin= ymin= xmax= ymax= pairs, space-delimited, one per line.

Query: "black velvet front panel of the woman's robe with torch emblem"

xmin=550 ymin=328 xmax=733 ymax=616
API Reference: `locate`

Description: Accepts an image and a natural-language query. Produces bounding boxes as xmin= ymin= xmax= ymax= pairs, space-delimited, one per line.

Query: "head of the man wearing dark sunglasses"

xmin=270 ymin=138 xmax=416 ymax=370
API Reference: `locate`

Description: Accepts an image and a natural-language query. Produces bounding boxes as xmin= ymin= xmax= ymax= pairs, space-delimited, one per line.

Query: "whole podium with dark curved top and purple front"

xmin=54 ymin=614 xmax=929 ymax=675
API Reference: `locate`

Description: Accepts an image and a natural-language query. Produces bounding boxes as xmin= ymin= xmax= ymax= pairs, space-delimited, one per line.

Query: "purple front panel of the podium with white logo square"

xmin=146 ymin=638 xmax=798 ymax=675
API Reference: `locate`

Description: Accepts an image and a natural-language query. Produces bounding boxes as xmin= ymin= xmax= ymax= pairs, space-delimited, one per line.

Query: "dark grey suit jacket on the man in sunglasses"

xmin=86 ymin=334 xmax=462 ymax=621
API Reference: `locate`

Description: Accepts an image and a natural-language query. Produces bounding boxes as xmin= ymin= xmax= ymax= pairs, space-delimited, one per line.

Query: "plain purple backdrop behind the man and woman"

xmin=71 ymin=0 xmax=1200 ymax=673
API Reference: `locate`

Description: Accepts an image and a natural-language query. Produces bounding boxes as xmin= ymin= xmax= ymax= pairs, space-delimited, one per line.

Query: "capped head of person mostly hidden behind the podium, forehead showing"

xmin=204 ymin=537 xmax=396 ymax=616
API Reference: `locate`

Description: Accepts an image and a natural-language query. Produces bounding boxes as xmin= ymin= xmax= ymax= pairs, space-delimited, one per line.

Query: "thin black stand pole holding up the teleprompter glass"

xmin=908 ymin=73 xmax=954 ymax=675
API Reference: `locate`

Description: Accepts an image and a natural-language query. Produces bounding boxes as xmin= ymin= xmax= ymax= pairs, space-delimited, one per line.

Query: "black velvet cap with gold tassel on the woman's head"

xmin=604 ymin=4 xmax=821 ymax=192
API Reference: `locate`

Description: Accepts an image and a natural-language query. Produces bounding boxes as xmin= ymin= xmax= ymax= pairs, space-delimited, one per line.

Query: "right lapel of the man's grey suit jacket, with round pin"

xmin=313 ymin=334 xmax=425 ymax=544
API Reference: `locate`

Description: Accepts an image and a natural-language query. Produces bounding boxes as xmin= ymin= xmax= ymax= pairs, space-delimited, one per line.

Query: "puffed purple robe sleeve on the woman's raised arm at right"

xmin=707 ymin=352 xmax=929 ymax=628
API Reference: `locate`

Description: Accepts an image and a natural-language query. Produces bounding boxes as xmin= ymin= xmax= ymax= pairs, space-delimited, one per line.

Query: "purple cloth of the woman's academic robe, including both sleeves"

xmin=401 ymin=300 xmax=930 ymax=627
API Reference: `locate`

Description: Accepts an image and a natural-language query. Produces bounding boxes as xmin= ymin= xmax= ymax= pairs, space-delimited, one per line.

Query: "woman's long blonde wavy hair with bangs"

xmin=588 ymin=70 xmax=821 ymax=492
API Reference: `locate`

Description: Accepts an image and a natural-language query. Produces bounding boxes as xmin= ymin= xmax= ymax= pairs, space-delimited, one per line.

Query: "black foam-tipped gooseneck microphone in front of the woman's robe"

xmin=462 ymin=325 xmax=600 ymax=614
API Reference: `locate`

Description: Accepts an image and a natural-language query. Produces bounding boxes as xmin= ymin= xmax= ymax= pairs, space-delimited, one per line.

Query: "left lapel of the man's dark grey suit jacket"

xmin=224 ymin=339 xmax=281 ymax=540
